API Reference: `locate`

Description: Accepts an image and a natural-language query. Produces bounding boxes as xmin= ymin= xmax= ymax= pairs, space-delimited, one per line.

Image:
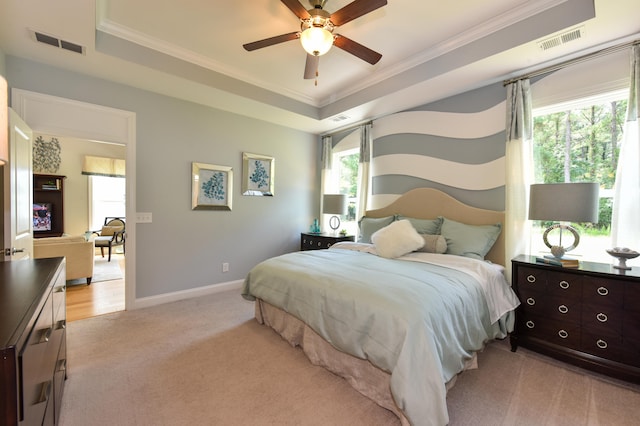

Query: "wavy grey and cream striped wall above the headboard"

xmin=370 ymin=84 xmax=506 ymax=210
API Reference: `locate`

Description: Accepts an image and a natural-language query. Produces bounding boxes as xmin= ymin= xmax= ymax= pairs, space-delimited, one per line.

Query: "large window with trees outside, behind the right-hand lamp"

xmin=531 ymin=90 xmax=628 ymax=263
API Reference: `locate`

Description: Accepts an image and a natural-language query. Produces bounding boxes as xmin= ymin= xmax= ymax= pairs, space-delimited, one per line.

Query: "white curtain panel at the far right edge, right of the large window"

xmin=611 ymin=44 xmax=640 ymax=250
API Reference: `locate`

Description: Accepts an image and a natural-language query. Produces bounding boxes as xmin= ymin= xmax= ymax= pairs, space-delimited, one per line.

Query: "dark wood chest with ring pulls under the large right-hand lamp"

xmin=511 ymin=255 xmax=640 ymax=383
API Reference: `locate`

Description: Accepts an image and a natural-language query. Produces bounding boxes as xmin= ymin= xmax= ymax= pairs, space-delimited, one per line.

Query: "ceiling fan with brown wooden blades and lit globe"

xmin=243 ymin=0 xmax=387 ymax=84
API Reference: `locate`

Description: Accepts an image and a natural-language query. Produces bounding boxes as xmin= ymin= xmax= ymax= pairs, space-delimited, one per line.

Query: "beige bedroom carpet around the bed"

xmin=61 ymin=291 xmax=640 ymax=426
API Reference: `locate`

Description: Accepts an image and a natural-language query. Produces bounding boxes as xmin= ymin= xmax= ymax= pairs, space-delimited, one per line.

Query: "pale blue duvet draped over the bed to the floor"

xmin=242 ymin=249 xmax=519 ymax=426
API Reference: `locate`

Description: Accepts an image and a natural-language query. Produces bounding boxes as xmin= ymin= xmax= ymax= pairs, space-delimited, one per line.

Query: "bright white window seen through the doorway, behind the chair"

xmin=89 ymin=176 xmax=126 ymax=231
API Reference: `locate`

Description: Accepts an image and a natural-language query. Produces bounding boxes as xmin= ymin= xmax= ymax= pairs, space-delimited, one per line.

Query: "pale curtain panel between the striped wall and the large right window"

xmin=503 ymin=79 xmax=533 ymax=282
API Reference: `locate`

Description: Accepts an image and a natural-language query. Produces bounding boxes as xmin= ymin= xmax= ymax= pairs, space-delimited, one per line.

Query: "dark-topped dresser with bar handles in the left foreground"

xmin=0 ymin=257 xmax=67 ymax=426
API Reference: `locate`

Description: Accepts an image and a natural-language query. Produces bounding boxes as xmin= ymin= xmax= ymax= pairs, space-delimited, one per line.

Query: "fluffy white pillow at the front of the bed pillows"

xmin=371 ymin=219 xmax=424 ymax=259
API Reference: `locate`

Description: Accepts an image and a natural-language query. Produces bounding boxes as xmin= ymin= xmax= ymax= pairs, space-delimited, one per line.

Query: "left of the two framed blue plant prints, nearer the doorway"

xmin=191 ymin=163 xmax=233 ymax=210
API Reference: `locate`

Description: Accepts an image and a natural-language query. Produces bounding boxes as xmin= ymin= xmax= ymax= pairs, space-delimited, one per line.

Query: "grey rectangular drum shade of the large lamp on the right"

xmin=529 ymin=182 xmax=599 ymax=223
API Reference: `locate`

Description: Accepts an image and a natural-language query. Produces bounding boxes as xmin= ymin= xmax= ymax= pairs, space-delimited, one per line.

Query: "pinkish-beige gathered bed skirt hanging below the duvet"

xmin=255 ymin=299 xmax=477 ymax=426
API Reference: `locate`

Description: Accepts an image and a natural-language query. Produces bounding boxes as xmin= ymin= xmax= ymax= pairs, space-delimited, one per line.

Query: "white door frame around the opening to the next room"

xmin=11 ymin=88 xmax=136 ymax=310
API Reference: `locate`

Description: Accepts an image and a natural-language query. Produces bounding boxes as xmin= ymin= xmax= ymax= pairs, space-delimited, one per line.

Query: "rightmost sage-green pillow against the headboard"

xmin=440 ymin=218 xmax=502 ymax=260
